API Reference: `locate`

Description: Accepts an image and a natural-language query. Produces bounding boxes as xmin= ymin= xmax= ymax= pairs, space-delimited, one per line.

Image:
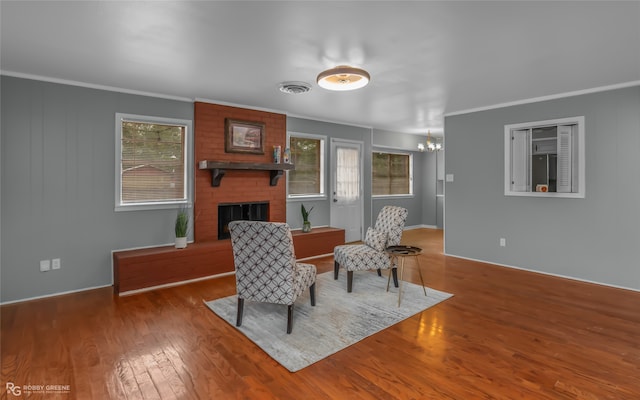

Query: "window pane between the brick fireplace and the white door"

xmin=289 ymin=136 xmax=322 ymax=195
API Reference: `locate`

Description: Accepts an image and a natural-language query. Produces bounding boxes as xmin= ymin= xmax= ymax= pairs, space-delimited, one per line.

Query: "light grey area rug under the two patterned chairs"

xmin=205 ymin=271 xmax=453 ymax=372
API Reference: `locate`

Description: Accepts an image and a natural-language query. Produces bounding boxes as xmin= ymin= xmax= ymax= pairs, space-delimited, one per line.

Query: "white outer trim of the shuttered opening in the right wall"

xmin=504 ymin=116 xmax=585 ymax=199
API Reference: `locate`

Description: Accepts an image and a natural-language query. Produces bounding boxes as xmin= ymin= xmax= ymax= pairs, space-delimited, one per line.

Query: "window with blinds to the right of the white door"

xmin=372 ymin=152 xmax=413 ymax=196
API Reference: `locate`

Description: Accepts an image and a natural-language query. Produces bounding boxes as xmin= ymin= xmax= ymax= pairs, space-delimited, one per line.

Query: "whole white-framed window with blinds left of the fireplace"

xmin=116 ymin=114 xmax=191 ymax=210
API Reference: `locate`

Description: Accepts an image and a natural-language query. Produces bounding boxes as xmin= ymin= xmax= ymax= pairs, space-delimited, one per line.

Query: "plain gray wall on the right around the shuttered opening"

xmin=445 ymin=86 xmax=640 ymax=290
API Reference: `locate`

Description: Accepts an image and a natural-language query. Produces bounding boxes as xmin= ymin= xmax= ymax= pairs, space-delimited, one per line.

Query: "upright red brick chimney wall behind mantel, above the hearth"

xmin=194 ymin=102 xmax=287 ymax=242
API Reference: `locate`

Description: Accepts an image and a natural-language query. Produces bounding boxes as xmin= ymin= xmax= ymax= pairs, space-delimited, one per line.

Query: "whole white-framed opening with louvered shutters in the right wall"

xmin=504 ymin=117 xmax=584 ymax=197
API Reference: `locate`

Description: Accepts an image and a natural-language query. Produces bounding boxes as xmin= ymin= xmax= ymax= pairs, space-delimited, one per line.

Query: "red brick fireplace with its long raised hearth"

xmin=113 ymin=102 xmax=344 ymax=293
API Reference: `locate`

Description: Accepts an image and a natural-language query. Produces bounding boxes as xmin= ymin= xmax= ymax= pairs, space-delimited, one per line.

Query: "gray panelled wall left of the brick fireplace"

xmin=0 ymin=76 xmax=193 ymax=302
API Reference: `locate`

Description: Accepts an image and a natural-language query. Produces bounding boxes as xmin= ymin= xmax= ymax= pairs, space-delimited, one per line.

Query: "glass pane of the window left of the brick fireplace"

xmin=121 ymin=120 xmax=186 ymax=205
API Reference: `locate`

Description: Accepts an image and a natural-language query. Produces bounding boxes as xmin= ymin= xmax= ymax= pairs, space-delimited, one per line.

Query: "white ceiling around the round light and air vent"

xmin=0 ymin=1 xmax=640 ymax=134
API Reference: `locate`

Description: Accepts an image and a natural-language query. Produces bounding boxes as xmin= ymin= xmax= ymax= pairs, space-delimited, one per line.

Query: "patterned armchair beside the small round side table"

xmin=333 ymin=206 xmax=408 ymax=293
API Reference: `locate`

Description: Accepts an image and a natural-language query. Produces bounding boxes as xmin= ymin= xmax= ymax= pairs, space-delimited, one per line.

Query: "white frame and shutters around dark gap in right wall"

xmin=504 ymin=116 xmax=585 ymax=198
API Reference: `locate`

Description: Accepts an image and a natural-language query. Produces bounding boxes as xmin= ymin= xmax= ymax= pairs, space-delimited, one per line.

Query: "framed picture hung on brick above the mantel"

xmin=224 ymin=118 xmax=265 ymax=154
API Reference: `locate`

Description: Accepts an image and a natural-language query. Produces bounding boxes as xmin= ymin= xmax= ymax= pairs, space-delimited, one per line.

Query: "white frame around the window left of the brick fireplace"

xmin=115 ymin=113 xmax=193 ymax=211
